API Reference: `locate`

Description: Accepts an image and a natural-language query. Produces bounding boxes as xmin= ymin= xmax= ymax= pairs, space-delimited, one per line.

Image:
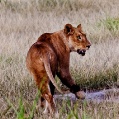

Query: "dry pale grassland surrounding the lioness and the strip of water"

xmin=0 ymin=0 xmax=119 ymax=119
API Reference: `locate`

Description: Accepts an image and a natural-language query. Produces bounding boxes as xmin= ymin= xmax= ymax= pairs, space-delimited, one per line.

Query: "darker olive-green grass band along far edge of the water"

xmin=71 ymin=65 xmax=119 ymax=90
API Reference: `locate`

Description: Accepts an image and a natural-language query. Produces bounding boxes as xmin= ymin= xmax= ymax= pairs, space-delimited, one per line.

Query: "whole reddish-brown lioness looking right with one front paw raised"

xmin=26 ymin=24 xmax=91 ymax=113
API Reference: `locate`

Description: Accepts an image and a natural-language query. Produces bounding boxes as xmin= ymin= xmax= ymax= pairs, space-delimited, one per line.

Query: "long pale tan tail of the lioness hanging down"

xmin=43 ymin=55 xmax=63 ymax=94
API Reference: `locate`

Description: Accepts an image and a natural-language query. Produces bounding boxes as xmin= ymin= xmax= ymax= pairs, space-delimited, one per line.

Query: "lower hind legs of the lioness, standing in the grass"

xmin=35 ymin=75 xmax=55 ymax=115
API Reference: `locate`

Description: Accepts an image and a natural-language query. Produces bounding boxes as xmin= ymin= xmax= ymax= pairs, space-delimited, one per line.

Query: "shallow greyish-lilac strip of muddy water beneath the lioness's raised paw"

xmin=54 ymin=88 xmax=119 ymax=103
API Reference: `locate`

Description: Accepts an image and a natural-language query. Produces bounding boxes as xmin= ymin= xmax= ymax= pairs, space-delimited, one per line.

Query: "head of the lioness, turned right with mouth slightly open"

xmin=64 ymin=24 xmax=91 ymax=56
